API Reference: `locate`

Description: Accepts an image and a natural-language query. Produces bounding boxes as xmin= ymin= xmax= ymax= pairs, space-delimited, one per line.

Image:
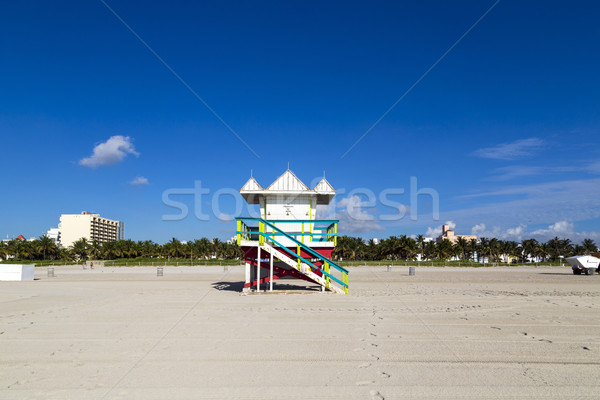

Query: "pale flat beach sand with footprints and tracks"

xmin=0 ymin=267 xmax=600 ymax=400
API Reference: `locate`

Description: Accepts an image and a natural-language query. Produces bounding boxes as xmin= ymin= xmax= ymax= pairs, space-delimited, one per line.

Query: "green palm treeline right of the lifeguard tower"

xmin=334 ymin=235 xmax=598 ymax=263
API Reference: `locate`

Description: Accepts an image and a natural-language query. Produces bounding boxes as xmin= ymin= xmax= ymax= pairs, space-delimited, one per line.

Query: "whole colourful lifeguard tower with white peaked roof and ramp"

xmin=237 ymin=169 xmax=348 ymax=294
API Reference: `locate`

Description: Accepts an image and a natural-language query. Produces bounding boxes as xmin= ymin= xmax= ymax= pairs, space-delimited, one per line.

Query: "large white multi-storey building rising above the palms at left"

xmin=58 ymin=211 xmax=124 ymax=247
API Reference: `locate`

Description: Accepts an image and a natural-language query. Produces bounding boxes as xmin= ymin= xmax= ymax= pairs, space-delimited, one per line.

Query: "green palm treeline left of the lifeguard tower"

xmin=0 ymin=235 xmax=243 ymax=262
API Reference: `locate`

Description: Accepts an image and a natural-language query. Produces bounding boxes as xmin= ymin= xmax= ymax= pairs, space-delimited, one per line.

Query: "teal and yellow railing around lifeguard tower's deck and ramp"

xmin=236 ymin=217 xmax=349 ymax=294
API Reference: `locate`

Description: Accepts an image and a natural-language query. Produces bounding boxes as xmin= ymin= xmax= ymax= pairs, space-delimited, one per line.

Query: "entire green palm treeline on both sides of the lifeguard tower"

xmin=0 ymin=235 xmax=598 ymax=263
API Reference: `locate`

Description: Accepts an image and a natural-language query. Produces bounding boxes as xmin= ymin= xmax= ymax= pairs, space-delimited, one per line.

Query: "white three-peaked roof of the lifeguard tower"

xmin=240 ymin=169 xmax=335 ymax=204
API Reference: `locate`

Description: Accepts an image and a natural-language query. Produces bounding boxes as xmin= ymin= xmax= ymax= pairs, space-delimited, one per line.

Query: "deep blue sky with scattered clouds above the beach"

xmin=0 ymin=0 xmax=600 ymax=242
